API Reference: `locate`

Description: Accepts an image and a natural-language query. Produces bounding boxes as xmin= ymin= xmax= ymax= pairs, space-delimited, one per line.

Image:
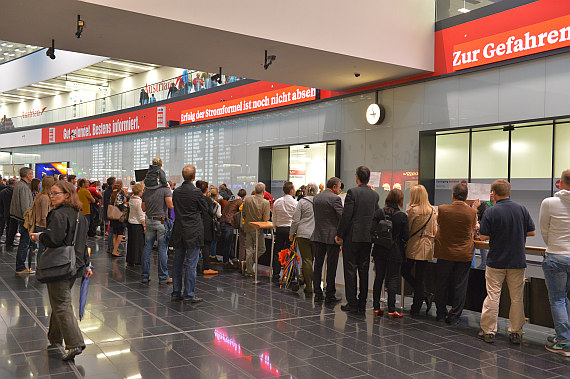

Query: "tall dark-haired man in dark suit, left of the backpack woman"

xmin=335 ymin=166 xmax=380 ymax=314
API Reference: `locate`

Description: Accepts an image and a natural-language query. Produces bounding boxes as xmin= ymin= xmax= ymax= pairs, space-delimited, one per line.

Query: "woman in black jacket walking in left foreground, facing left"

xmin=31 ymin=180 xmax=93 ymax=361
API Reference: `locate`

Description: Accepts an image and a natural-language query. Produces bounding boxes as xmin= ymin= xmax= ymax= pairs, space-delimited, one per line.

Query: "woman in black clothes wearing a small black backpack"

xmin=372 ymin=189 xmax=410 ymax=318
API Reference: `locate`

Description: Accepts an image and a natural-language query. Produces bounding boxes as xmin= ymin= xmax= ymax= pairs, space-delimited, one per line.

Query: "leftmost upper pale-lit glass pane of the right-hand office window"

xmin=435 ymin=133 xmax=469 ymax=179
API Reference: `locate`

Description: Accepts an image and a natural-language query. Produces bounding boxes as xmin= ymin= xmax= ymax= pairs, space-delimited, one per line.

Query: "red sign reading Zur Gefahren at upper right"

xmin=453 ymin=14 xmax=570 ymax=71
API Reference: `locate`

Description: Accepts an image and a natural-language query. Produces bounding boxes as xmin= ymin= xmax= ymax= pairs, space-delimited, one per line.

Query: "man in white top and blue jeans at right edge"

xmin=540 ymin=170 xmax=570 ymax=357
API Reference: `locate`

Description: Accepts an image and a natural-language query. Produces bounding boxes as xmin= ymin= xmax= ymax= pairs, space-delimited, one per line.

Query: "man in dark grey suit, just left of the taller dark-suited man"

xmin=311 ymin=177 xmax=342 ymax=304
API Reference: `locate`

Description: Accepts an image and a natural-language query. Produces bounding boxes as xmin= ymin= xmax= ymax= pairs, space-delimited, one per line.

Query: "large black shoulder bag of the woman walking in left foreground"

xmin=36 ymin=212 xmax=79 ymax=283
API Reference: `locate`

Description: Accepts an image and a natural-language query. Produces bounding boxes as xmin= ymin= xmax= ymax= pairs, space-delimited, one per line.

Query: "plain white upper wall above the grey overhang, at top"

xmin=83 ymin=0 xmax=435 ymax=71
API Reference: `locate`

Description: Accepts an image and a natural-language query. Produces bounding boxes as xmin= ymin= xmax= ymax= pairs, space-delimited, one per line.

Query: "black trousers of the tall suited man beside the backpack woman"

xmin=342 ymin=241 xmax=372 ymax=309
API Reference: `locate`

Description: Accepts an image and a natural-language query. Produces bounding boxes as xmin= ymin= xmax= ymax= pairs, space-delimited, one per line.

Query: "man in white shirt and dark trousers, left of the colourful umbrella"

xmin=273 ymin=182 xmax=297 ymax=283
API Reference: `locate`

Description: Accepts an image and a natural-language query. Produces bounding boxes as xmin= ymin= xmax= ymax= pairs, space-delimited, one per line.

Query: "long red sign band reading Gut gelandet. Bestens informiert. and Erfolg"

xmin=42 ymin=82 xmax=317 ymax=144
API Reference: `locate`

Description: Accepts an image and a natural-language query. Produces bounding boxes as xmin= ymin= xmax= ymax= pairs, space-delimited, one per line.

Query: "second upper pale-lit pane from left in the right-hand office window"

xmin=471 ymin=129 xmax=509 ymax=182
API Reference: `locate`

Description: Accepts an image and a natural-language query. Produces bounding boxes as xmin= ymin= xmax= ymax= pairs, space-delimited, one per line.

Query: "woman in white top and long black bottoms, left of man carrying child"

xmin=127 ymin=184 xmax=145 ymax=266
